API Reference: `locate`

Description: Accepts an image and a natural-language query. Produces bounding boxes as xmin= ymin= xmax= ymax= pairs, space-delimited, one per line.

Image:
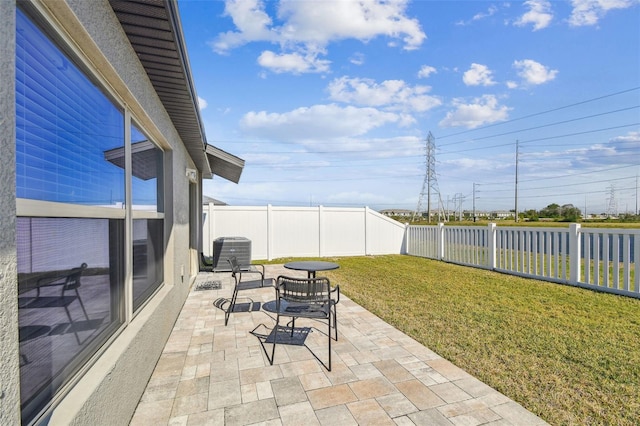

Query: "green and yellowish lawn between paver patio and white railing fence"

xmin=268 ymin=255 xmax=640 ymax=425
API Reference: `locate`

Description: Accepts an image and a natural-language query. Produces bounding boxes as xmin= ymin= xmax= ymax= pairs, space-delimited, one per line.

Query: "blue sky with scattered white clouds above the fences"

xmin=179 ymin=0 xmax=640 ymax=213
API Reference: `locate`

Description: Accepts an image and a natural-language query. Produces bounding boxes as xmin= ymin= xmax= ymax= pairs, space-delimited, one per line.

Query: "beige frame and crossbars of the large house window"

xmin=16 ymin=5 xmax=172 ymax=422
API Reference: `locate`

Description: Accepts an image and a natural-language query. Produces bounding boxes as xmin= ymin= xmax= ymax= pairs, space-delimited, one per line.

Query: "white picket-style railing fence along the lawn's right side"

xmin=406 ymin=224 xmax=640 ymax=298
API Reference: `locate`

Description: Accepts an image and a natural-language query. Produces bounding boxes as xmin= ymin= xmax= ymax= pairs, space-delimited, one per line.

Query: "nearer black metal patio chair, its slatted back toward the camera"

xmin=269 ymin=275 xmax=340 ymax=371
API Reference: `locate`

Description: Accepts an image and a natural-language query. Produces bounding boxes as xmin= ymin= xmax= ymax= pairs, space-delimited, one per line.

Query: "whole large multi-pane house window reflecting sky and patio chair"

xmin=16 ymin=10 xmax=164 ymax=424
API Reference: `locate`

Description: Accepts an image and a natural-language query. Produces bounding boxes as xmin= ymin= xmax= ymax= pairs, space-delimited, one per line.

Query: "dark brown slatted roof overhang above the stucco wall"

xmin=109 ymin=0 xmax=244 ymax=182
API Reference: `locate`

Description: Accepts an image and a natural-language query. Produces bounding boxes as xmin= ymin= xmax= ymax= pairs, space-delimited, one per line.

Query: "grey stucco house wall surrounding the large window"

xmin=0 ymin=0 xmax=229 ymax=425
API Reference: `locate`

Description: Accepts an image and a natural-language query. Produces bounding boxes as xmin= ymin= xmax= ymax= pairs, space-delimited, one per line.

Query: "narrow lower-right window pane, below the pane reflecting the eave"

xmin=133 ymin=219 xmax=164 ymax=310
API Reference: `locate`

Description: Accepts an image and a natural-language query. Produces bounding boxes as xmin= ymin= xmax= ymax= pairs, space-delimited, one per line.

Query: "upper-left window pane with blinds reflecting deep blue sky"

xmin=16 ymin=7 xmax=124 ymax=206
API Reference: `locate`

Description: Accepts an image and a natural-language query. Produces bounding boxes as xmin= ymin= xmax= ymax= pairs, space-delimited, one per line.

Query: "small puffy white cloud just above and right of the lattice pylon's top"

xmin=438 ymin=95 xmax=510 ymax=129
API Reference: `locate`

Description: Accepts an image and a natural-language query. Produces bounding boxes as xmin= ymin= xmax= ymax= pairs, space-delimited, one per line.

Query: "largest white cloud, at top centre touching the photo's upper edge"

xmin=210 ymin=0 xmax=426 ymax=73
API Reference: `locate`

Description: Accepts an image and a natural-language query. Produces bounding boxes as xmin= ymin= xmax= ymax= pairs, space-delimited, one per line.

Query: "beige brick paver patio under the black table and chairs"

xmin=131 ymin=265 xmax=546 ymax=426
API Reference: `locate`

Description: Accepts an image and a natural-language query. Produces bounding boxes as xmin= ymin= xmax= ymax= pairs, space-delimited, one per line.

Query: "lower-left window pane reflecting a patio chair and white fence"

xmin=17 ymin=217 xmax=124 ymax=423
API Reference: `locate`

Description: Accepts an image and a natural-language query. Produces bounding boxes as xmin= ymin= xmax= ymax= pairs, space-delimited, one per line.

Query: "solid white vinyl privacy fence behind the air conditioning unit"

xmin=202 ymin=204 xmax=406 ymax=260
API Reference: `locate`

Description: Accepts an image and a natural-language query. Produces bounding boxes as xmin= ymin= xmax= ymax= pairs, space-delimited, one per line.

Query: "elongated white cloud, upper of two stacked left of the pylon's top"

xmin=327 ymin=77 xmax=442 ymax=112
